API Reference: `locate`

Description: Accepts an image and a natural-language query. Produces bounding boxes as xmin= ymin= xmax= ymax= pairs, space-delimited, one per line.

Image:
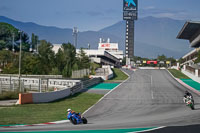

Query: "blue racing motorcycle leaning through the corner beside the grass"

xmin=68 ymin=113 xmax=87 ymax=125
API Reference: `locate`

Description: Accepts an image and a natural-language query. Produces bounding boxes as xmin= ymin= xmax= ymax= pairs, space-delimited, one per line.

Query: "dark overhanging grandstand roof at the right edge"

xmin=177 ymin=21 xmax=200 ymax=47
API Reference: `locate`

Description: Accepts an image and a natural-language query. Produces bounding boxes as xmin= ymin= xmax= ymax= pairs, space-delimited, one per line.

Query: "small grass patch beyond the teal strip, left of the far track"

xmin=106 ymin=68 xmax=128 ymax=82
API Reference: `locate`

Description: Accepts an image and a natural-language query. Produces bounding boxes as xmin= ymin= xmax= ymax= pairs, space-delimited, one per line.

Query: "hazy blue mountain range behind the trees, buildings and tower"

xmin=0 ymin=16 xmax=191 ymax=58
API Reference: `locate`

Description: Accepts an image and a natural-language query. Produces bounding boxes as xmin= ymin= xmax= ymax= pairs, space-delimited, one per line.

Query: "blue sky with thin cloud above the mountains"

xmin=0 ymin=0 xmax=200 ymax=31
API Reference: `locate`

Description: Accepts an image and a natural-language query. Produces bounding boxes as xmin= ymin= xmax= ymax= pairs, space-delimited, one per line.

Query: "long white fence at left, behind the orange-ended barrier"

xmin=0 ymin=76 xmax=80 ymax=93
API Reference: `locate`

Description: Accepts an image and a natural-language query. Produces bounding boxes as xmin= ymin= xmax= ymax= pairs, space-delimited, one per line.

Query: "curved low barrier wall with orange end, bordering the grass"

xmin=19 ymin=78 xmax=102 ymax=104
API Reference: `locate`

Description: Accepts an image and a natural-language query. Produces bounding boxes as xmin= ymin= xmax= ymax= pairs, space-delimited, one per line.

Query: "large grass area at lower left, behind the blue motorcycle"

xmin=0 ymin=93 xmax=103 ymax=125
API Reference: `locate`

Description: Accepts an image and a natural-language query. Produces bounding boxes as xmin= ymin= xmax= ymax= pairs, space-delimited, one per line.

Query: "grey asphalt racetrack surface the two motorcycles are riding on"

xmin=0 ymin=70 xmax=200 ymax=132
